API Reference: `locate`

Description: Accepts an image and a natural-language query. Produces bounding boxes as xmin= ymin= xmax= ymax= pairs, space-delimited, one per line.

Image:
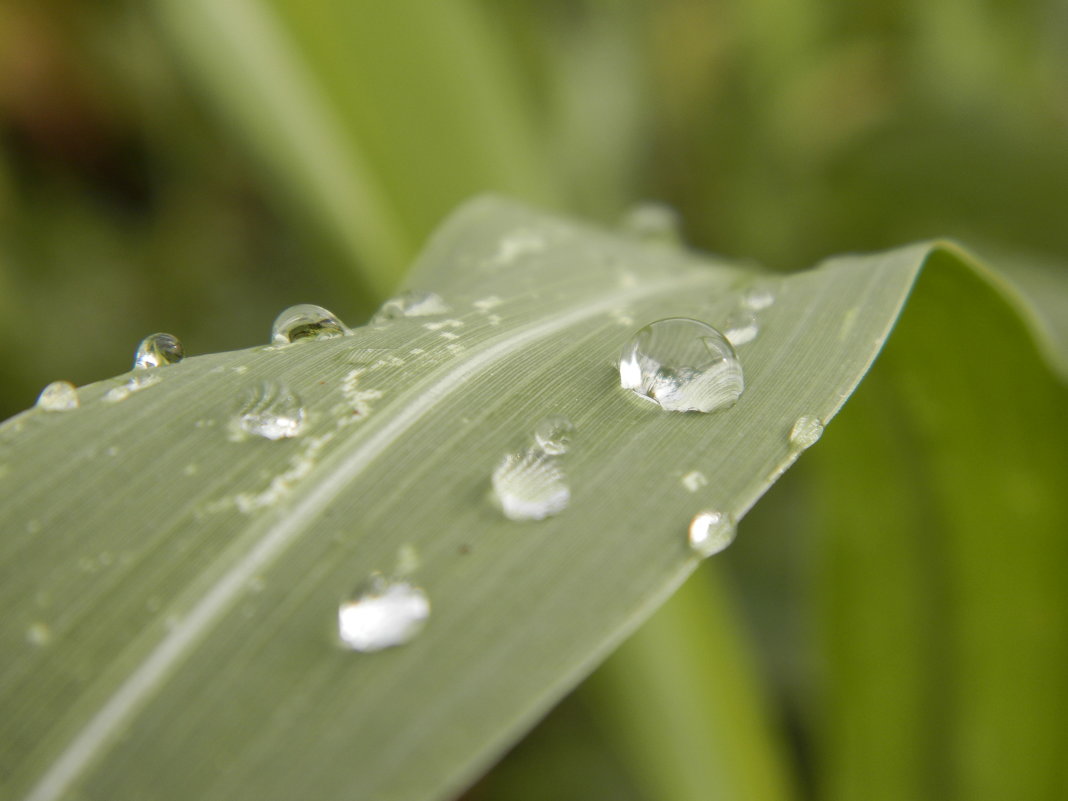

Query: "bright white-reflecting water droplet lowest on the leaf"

xmin=337 ymin=574 xmax=430 ymax=653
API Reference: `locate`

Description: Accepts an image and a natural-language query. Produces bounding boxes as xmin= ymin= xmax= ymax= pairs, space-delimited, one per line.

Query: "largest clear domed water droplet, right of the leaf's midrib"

xmin=619 ymin=317 xmax=744 ymax=411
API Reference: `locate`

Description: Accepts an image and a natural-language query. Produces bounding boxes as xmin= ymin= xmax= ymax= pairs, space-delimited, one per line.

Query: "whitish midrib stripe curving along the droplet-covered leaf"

xmin=25 ymin=270 xmax=720 ymax=801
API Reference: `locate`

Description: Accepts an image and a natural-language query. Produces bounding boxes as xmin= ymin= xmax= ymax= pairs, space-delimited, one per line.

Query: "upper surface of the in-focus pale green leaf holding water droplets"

xmin=0 ymin=200 xmax=1059 ymax=801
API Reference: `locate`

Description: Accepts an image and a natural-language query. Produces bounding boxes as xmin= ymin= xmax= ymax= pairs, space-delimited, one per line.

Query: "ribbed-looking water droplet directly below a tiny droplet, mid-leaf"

xmin=491 ymin=449 xmax=571 ymax=520
